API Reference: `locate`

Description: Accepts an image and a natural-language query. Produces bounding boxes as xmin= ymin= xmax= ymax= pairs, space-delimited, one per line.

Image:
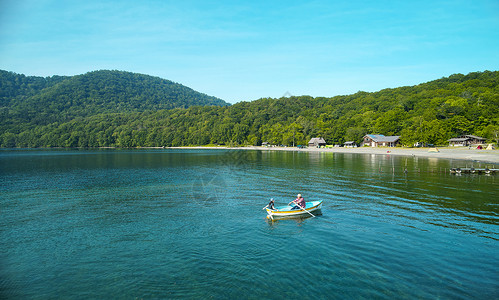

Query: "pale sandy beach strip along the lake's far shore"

xmin=169 ymin=146 xmax=499 ymax=164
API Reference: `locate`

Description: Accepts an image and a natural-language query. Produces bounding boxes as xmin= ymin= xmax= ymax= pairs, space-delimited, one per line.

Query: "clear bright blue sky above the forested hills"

xmin=0 ymin=0 xmax=499 ymax=103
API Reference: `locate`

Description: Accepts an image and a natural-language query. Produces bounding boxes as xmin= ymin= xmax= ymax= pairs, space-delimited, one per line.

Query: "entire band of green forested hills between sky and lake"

xmin=0 ymin=71 xmax=499 ymax=148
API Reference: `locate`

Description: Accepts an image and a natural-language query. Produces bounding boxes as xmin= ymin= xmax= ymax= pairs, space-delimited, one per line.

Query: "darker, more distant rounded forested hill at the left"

xmin=0 ymin=70 xmax=229 ymax=125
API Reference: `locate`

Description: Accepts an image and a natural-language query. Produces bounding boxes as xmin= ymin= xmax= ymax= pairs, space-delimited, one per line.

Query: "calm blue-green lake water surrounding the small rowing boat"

xmin=0 ymin=150 xmax=499 ymax=299
